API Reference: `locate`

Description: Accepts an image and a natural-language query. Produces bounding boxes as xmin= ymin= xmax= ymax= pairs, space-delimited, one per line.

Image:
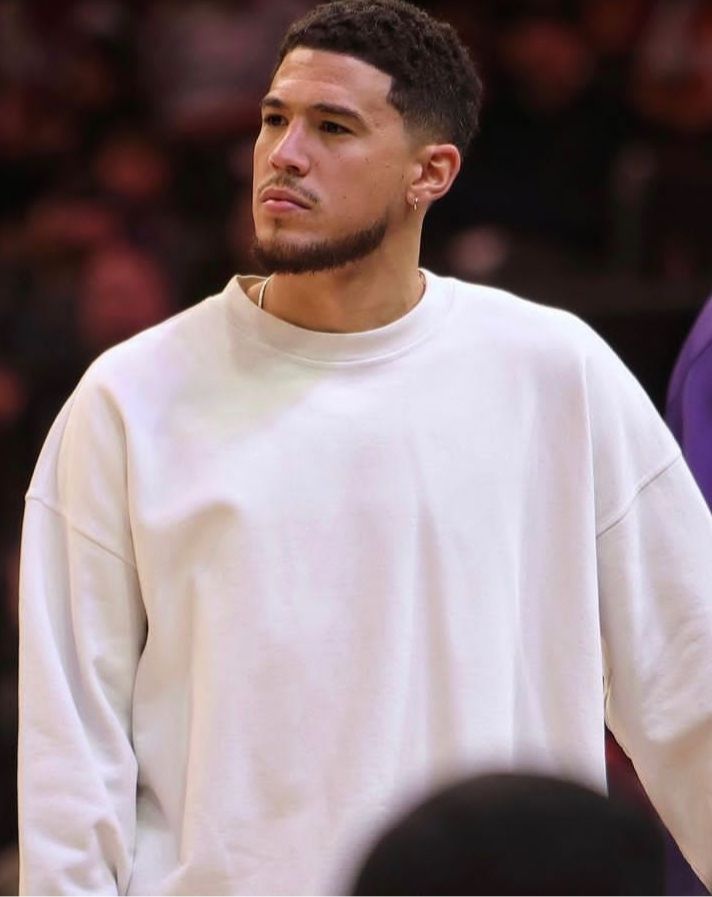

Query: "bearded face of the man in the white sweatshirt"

xmin=253 ymin=47 xmax=414 ymax=273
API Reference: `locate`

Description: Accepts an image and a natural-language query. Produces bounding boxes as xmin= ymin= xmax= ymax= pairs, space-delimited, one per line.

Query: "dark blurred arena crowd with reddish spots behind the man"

xmin=0 ymin=0 xmax=712 ymax=893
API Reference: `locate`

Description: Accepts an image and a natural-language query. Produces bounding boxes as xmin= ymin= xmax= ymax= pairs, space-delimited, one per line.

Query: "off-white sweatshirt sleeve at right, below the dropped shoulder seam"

xmin=598 ymin=459 xmax=712 ymax=887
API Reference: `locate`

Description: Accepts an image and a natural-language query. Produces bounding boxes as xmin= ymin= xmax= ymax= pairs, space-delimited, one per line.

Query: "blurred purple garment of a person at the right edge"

xmin=665 ymin=296 xmax=712 ymax=507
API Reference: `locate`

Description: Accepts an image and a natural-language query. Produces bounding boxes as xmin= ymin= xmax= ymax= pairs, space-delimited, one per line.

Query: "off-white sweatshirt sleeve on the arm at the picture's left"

xmin=18 ymin=376 xmax=146 ymax=894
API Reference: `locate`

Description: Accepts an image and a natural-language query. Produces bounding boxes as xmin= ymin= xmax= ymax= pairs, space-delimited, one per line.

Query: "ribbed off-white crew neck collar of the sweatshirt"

xmin=225 ymin=268 xmax=451 ymax=363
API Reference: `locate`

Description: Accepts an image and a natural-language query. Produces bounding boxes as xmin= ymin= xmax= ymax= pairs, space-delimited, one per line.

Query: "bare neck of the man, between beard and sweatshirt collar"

xmin=250 ymin=243 xmax=424 ymax=333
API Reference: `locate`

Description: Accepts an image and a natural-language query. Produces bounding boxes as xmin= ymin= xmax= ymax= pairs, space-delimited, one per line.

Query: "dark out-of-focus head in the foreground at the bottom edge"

xmin=351 ymin=773 xmax=664 ymax=895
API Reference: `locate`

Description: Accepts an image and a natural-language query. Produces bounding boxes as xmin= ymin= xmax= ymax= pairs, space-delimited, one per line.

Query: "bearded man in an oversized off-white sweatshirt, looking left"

xmin=20 ymin=0 xmax=712 ymax=894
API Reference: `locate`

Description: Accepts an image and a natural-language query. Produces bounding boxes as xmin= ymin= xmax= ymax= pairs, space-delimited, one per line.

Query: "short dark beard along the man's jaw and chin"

xmin=252 ymin=215 xmax=388 ymax=274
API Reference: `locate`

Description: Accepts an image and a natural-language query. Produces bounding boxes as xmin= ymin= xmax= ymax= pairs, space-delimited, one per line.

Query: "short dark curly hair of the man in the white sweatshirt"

xmin=275 ymin=0 xmax=482 ymax=156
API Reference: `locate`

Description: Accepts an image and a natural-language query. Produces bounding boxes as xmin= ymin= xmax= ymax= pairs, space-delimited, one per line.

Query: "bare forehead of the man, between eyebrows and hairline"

xmin=270 ymin=47 xmax=400 ymax=119
